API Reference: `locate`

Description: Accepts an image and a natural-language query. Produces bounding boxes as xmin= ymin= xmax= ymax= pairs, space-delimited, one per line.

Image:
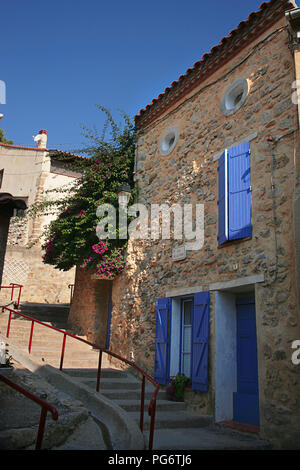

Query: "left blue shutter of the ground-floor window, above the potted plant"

xmin=154 ymin=298 xmax=169 ymax=385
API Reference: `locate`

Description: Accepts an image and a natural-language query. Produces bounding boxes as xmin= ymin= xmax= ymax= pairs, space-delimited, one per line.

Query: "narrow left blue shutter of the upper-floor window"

xmin=218 ymin=151 xmax=228 ymax=245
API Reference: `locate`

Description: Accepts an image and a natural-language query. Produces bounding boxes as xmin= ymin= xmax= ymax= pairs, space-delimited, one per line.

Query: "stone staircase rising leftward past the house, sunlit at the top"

xmin=0 ymin=304 xmax=272 ymax=450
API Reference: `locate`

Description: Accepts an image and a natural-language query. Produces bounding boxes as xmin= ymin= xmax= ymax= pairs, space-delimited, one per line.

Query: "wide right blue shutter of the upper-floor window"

xmin=228 ymin=142 xmax=252 ymax=240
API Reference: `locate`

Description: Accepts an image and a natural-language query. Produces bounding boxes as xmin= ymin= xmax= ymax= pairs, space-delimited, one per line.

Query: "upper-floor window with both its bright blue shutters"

xmin=218 ymin=142 xmax=252 ymax=245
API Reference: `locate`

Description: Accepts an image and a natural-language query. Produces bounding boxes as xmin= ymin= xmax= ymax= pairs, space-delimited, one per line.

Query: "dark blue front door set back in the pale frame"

xmin=233 ymin=297 xmax=259 ymax=425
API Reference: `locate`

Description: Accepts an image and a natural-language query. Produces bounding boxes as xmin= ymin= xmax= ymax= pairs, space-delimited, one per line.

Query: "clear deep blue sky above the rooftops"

xmin=0 ymin=0 xmax=262 ymax=151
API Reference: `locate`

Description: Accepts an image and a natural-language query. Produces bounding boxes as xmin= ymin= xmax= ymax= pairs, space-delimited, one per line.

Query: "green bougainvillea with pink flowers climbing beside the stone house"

xmin=31 ymin=106 xmax=136 ymax=278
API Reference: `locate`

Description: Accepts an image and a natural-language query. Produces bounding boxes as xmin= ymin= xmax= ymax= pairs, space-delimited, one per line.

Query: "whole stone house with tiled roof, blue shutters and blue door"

xmin=70 ymin=0 xmax=300 ymax=448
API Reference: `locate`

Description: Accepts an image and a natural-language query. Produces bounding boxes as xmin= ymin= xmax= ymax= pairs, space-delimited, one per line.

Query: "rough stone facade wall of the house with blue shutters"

xmin=111 ymin=20 xmax=300 ymax=446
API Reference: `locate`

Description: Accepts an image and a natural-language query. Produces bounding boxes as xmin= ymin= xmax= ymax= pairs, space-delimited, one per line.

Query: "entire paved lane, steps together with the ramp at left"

xmin=0 ymin=306 xmax=270 ymax=450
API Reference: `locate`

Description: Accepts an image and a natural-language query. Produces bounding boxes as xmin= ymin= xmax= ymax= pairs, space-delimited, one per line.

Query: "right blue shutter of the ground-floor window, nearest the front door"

xmin=192 ymin=292 xmax=209 ymax=392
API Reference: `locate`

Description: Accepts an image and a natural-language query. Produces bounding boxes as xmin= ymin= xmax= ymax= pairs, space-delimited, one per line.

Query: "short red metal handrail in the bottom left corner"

xmin=0 ymin=374 xmax=58 ymax=450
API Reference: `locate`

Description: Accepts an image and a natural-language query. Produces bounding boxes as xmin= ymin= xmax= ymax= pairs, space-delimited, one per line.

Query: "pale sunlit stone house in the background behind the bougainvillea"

xmin=0 ymin=130 xmax=83 ymax=304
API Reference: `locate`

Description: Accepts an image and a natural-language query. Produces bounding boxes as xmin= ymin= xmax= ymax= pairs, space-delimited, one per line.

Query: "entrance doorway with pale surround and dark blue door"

xmin=215 ymin=291 xmax=259 ymax=425
